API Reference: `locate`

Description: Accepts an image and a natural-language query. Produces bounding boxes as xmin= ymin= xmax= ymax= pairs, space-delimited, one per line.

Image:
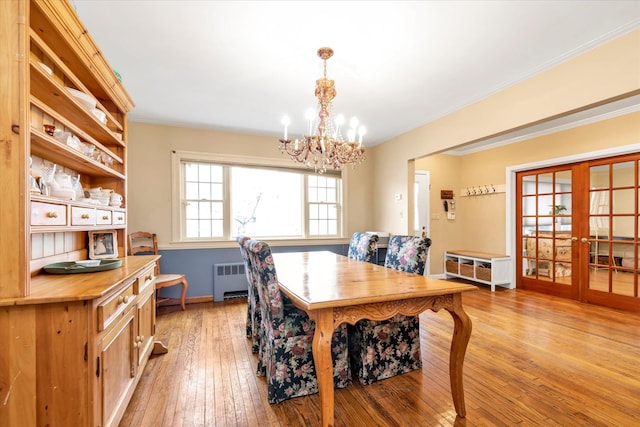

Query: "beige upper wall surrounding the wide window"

xmin=127 ymin=122 xmax=373 ymax=248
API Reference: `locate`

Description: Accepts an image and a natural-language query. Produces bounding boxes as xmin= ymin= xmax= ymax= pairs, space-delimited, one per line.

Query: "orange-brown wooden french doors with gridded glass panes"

xmin=516 ymin=154 xmax=640 ymax=311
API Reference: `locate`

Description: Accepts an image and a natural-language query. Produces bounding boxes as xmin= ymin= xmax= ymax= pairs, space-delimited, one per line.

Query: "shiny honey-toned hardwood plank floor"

xmin=120 ymin=287 xmax=640 ymax=427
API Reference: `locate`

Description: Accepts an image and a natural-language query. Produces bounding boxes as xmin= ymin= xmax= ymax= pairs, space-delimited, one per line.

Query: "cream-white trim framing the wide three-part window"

xmin=171 ymin=150 xmax=348 ymax=248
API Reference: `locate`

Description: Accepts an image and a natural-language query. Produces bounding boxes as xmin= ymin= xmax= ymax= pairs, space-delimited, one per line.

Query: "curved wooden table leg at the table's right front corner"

xmin=445 ymin=294 xmax=472 ymax=417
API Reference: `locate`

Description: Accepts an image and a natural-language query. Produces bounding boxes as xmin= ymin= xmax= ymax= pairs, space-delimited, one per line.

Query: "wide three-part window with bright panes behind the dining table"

xmin=172 ymin=152 xmax=342 ymax=241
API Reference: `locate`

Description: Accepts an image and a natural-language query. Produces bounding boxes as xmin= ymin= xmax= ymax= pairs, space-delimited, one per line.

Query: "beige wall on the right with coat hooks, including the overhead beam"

xmin=372 ymin=30 xmax=640 ymax=274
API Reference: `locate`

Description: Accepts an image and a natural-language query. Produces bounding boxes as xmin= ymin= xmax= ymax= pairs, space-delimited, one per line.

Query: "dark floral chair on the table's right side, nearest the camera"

xmin=349 ymin=236 xmax=431 ymax=385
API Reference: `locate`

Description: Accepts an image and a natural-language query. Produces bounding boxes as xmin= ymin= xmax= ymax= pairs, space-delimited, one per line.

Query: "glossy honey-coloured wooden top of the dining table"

xmin=273 ymin=251 xmax=477 ymax=310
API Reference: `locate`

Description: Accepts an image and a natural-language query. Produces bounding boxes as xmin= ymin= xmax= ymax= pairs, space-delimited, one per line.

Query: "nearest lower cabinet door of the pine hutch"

xmin=98 ymin=306 xmax=137 ymax=427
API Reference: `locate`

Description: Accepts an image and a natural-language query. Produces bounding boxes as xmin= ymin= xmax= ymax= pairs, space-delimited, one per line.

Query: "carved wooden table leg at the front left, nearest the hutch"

xmin=313 ymin=309 xmax=334 ymax=427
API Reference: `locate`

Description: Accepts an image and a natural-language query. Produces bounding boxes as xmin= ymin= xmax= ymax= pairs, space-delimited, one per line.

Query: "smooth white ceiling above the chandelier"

xmin=72 ymin=0 xmax=640 ymax=146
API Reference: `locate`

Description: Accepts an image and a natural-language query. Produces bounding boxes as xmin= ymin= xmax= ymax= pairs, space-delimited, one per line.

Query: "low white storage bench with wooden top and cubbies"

xmin=444 ymin=250 xmax=515 ymax=292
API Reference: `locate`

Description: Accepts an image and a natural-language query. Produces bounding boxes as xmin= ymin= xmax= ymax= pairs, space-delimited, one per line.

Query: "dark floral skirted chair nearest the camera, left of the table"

xmin=244 ymin=240 xmax=351 ymax=403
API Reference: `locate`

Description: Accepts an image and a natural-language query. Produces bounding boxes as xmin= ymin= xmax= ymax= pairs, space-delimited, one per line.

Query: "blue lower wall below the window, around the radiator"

xmin=160 ymin=245 xmax=349 ymax=298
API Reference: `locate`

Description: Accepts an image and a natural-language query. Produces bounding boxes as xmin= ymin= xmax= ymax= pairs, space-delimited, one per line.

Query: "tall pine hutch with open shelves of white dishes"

xmin=0 ymin=0 xmax=157 ymax=427
